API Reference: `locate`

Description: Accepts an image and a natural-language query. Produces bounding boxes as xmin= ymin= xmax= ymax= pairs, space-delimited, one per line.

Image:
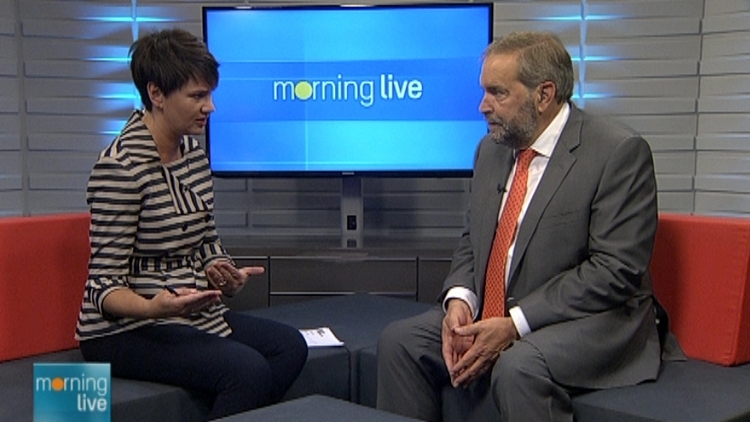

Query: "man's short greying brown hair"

xmin=484 ymin=32 xmax=575 ymax=104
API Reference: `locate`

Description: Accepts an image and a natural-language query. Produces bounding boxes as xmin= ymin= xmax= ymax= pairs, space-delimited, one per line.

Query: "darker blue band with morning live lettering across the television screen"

xmin=211 ymin=56 xmax=482 ymax=122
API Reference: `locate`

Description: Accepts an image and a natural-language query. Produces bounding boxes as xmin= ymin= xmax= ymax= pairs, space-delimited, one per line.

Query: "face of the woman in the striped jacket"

xmin=162 ymin=79 xmax=216 ymax=136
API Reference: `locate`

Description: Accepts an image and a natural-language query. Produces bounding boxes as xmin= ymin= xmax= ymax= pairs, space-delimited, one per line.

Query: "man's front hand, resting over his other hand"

xmin=443 ymin=318 xmax=518 ymax=387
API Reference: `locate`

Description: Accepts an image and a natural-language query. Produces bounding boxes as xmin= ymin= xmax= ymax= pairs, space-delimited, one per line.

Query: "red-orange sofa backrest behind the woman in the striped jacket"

xmin=0 ymin=213 xmax=91 ymax=361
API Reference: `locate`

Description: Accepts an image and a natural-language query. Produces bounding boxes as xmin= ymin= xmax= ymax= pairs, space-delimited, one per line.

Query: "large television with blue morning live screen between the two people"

xmin=203 ymin=3 xmax=493 ymax=177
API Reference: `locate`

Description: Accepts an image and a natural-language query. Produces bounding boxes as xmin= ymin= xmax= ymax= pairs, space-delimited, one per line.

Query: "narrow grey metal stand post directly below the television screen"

xmin=341 ymin=175 xmax=364 ymax=248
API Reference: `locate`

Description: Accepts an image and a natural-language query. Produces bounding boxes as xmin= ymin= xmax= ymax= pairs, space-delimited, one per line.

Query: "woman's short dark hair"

xmin=129 ymin=28 xmax=219 ymax=111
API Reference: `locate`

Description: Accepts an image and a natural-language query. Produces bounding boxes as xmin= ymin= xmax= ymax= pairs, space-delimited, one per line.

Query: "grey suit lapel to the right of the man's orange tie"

xmin=508 ymin=104 xmax=582 ymax=289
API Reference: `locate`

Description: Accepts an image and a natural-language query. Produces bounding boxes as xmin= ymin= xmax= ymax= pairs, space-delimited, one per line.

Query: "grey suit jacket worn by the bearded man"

xmin=444 ymin=104 xmax=660 ymax=388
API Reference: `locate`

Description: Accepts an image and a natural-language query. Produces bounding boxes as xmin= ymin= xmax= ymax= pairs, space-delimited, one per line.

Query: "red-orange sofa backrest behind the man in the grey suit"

xmin=651 ymin=214 xmax=750 ymax=366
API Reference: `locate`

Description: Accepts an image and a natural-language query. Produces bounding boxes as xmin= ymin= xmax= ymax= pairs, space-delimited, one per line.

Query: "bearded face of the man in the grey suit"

xmin=479 ymin=54 xmax=538 ymax=149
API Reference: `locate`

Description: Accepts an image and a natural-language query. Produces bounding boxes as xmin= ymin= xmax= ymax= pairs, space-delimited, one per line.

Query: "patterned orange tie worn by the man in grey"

xmin=482 ymin=148 xmax=535 ymax=319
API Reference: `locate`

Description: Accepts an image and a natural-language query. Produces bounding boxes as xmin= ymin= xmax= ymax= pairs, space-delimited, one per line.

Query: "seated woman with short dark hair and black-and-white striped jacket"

xmin=76 ymin=29 xmax=307 ymax=419
